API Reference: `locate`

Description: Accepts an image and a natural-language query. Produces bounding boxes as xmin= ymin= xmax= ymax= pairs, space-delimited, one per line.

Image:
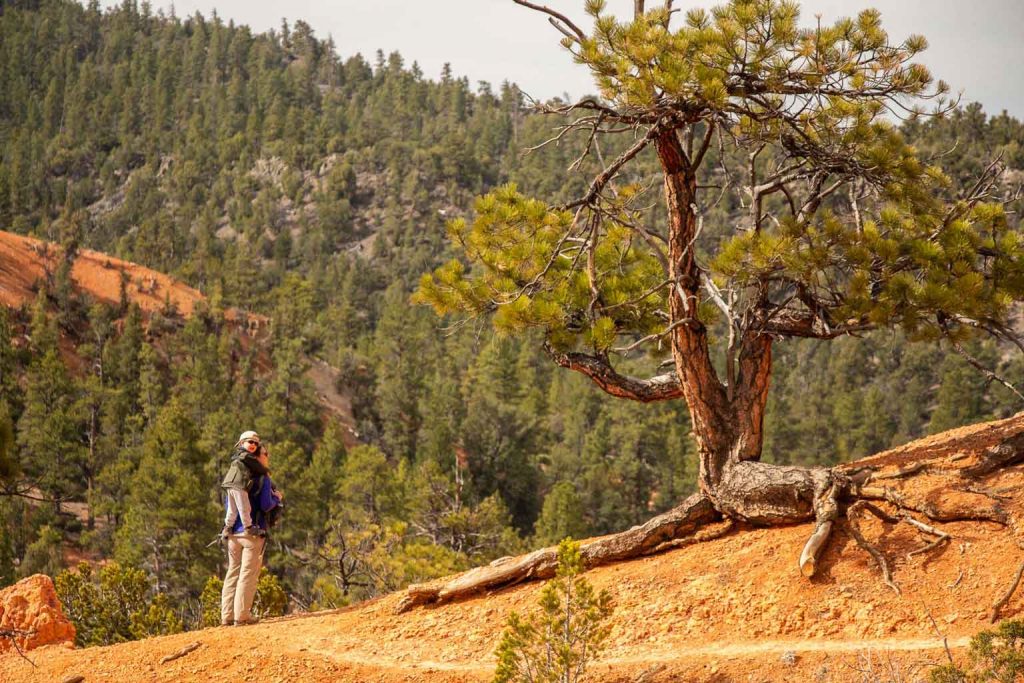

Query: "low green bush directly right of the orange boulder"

xmin=54 ymin=562 xmax=183 ymax=646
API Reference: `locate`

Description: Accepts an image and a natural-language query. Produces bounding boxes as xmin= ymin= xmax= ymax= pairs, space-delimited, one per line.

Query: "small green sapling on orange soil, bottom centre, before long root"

xmin=494 ymin=539 xmax=612 ymax=683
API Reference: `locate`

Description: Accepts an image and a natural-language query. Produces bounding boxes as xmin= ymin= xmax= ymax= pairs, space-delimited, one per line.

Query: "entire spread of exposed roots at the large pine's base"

xmin=396 ymin=432 xmax=1024 ymax=620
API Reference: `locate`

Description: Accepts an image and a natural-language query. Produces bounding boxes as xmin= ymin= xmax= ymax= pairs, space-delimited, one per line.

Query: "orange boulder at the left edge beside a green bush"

xmin=0 ymin=573 xmax=75 ymax=652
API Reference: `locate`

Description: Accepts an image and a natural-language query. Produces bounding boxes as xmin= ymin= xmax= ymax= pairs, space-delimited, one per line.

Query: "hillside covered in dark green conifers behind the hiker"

xmin=0 ymin=0 xmax=1024 ymax=625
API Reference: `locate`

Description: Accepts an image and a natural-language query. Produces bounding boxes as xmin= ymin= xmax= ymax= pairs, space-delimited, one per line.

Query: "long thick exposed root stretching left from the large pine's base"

xmin=395 ymin=494 xmax=721 ymax=613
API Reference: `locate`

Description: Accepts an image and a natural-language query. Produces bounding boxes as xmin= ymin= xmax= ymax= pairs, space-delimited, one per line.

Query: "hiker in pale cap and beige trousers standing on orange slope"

xmin=220 ymin=432 xmax=284 ymax=626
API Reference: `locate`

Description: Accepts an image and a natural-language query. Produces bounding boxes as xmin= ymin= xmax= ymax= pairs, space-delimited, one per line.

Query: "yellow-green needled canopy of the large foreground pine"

xmin=418 ymin=0 xmax=1024 ymax=389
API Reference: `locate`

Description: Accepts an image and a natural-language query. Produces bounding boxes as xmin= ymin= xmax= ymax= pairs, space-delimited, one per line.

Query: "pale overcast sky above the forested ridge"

xmin=101 ymin=0 xmax=1024 ymax=119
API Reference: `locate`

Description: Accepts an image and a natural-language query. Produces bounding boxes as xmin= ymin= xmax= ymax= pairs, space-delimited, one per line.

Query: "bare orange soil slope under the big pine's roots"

xmin=0 ymin=415 xmax=1024 ymax=683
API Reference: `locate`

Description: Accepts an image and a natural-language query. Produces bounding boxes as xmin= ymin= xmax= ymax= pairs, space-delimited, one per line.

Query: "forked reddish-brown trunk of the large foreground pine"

xmin=655 ymin=129 xmax=830 ymax=524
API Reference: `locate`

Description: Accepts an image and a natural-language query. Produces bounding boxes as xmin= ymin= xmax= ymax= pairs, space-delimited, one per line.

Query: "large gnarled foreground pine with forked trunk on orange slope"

xmin=406 ymin=0 xmax=1024 ymax=606
